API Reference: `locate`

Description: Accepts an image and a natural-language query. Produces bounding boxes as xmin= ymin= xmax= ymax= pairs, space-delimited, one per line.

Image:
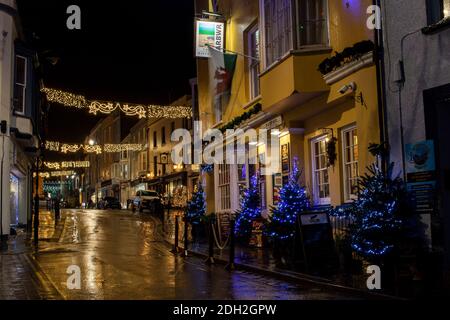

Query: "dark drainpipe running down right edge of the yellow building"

xmin=373 ymin=0 xmax=390 ymax=171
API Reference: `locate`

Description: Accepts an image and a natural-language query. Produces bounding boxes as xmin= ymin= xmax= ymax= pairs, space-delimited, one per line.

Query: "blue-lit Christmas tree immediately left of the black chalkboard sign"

xmin=266 ymin=159 xmax=310 ymax=241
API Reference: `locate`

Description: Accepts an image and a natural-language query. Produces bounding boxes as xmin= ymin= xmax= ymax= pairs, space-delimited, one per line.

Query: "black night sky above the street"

xmin=17 ymin=0 xmax=195 ymax=143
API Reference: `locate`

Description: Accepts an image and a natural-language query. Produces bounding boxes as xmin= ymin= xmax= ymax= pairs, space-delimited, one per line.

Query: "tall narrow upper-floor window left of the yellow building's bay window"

xmin=247 ymin=23 xmax=261 ymax=101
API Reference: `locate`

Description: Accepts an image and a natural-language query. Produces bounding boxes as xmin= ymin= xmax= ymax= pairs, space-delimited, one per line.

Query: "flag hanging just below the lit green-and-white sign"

xmin=209 ymin=47 xmax=237 ymax=102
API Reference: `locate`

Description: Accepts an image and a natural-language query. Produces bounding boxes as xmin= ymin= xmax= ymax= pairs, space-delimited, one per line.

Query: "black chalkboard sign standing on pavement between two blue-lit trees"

xmin=298 ymin=211 xmax=337 ymax=271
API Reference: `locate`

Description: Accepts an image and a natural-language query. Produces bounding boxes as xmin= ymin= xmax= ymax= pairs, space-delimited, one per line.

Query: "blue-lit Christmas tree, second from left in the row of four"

xmin=234 ymin=175 xmax=261 ymax=242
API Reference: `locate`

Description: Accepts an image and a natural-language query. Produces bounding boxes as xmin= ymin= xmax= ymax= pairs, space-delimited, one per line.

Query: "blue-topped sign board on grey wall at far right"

xmin=405 ymin=140 xmax=436 ymax=214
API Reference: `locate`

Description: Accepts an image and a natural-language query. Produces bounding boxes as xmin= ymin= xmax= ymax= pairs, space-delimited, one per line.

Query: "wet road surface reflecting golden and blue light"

xmin=34 ymin=210 xmax=358 ymax=300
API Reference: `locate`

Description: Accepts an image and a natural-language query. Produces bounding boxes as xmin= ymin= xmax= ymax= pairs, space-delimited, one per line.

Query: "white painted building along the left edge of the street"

xmin=0 ymin=0 xmax=43 ymax=238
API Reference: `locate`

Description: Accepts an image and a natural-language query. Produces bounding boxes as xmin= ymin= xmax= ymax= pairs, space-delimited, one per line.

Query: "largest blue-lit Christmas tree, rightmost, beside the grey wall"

xmin=331 ymin=145 xmax=420 ymax=262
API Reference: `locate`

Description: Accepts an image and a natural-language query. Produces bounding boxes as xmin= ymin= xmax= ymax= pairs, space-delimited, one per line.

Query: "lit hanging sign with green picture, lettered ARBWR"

xmin=195 ymin=20 xmax=225 ymax=58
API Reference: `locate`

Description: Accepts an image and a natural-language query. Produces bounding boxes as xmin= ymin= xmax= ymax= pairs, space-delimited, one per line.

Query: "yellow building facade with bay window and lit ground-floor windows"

xmin=196 ymin=0 xmax=380 ymax=215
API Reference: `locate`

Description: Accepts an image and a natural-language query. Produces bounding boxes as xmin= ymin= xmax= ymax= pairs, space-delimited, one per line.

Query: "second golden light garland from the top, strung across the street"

xmin=45 ymin=141 xmax=144 ymax=154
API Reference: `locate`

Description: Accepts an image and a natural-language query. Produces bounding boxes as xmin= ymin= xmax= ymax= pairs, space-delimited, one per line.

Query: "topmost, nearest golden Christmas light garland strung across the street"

xmin=41 ymin=88 xmax=192 ymax=119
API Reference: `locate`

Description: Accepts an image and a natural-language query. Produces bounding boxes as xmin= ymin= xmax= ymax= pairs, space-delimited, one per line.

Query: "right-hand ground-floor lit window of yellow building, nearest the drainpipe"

xmin=342 ymin=127 xmax=359 ymax=201
